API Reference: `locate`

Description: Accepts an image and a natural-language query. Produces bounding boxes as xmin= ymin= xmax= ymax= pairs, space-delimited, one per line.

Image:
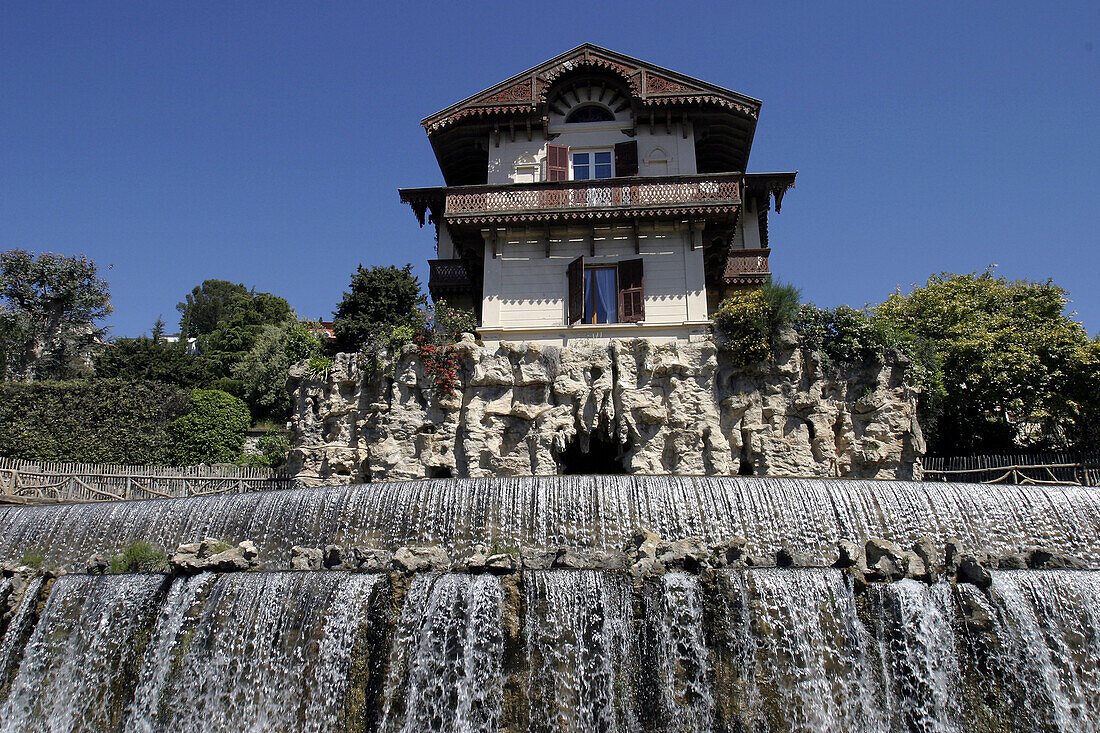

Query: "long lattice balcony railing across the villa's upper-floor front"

xmin=443 ymin=173 xmax=740 ymax=222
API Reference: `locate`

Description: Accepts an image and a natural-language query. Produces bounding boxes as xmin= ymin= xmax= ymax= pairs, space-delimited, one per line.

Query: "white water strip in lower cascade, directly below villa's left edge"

xmin=382 ymin=573 xmax=504 ymax=733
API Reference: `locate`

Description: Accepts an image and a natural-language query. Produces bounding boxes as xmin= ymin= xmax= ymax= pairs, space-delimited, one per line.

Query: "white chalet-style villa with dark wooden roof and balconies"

xmin=399 ymin=44 xmax=795 ymax=346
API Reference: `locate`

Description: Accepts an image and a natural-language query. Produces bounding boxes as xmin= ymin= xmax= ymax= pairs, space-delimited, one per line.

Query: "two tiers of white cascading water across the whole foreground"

xmin=0 ymin=477 xmax=1100 ymax=733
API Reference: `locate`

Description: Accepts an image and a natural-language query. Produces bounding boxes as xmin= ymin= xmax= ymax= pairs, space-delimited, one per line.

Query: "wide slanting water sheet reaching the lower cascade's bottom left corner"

xmin=0 ymin=576 xmax=165 ymax=733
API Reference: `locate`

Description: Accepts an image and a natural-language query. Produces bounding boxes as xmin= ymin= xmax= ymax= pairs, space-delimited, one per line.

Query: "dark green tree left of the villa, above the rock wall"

xmin=332 ymin=264 xmax=427 ymax=351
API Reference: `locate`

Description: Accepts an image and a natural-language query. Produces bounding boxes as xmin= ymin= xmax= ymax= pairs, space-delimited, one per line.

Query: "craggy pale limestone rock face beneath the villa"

xmin=290 ymin=333 xmax=924 ymax=484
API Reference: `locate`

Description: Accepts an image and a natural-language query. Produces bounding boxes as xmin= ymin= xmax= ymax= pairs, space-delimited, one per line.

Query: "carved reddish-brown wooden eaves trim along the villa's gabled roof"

xmin=421 ymin=43 xmax=760 ymax=135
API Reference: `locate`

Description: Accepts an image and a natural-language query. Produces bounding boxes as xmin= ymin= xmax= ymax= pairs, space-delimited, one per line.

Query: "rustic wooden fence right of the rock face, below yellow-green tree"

xmin=922 ymin=452 xmax=1100 ymax=486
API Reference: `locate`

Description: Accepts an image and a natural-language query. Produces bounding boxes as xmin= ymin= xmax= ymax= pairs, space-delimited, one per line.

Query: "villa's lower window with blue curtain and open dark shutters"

xmin=568 ymin=258 xmax=646 ymax=324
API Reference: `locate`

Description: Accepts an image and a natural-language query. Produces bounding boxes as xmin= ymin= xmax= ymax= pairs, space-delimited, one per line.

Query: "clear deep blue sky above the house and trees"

xmin=0 ymin=0 xmax=1100 ymax=336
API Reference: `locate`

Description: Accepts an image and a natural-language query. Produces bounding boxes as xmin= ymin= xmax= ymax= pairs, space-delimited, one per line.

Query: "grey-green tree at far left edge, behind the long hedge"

xmin=0 ymin=250 xmax=111 ymax=380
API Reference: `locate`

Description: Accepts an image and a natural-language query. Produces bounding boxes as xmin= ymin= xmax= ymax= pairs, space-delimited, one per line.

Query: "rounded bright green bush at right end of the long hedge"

xmin=172 ymin=390 xmax=252 ymax=466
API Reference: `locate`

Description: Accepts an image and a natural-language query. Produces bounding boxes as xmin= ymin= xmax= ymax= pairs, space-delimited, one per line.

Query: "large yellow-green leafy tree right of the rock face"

xmin=876 ymin=269 xmax=1095 ymax=455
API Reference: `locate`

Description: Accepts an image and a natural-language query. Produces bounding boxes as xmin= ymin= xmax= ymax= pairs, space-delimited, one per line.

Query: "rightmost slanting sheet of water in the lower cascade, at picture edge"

xmin=992 ymin=570 xmax=1100 ymax=733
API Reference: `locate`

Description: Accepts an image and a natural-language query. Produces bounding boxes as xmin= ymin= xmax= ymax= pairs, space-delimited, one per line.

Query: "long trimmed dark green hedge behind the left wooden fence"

xmin=0 ymin=379 xmax=188 ymax=464
